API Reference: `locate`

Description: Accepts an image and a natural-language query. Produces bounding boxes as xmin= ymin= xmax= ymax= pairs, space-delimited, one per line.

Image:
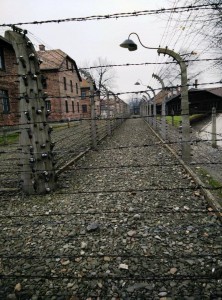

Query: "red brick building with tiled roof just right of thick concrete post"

xmin=37 ymin=45 xmax=82 ymax=121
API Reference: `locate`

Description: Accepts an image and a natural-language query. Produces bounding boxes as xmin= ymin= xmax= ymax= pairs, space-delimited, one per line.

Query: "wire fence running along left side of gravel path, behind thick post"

xmin=0 ymin=115 xmax=126 ymax=192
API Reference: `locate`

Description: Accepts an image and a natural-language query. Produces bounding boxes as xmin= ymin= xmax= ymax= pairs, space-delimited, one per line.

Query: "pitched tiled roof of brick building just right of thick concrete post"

xmin=37 ymin=49 xmax=82 ymax=81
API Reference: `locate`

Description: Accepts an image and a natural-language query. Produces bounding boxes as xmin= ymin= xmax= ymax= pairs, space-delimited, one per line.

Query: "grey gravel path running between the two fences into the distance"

xmin=0 ymin=119 xmax=222 ymax=300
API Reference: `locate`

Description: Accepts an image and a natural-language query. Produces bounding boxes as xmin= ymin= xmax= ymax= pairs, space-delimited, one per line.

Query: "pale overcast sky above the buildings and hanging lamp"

xmin=0 ymin=0 xmax=221 ymax=99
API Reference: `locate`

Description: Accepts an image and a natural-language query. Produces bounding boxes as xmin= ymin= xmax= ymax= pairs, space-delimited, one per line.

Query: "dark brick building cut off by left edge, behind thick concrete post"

xmin=0 ymin=36 xmax=19 ymax=126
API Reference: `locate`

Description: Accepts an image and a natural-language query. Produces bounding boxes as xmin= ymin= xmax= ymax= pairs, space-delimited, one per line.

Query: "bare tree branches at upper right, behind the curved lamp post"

xmin=159 ymin=0 xmax=222 ymax=86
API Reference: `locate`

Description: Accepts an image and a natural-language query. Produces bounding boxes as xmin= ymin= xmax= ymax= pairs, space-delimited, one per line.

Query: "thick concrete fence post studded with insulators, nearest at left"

xmin=5 ymin=26 xmax=55 ymax=194
